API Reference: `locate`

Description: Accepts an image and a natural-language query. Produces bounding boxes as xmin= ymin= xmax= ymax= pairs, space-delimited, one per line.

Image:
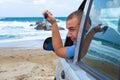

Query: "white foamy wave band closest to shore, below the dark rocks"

xmin=0 ymin=30 xmax=67 ymax=43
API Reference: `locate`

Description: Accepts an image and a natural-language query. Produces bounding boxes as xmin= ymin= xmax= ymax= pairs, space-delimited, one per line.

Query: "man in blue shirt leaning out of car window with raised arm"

xmin=43 ymin=10 xmax=102 ymax=58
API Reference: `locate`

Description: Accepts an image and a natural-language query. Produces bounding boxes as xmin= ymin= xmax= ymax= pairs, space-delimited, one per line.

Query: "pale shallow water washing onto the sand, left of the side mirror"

xmin=0 ymin=39 xmax=44 ymax=48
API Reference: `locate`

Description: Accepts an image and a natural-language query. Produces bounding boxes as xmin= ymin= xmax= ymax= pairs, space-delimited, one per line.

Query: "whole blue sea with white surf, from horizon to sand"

xmin=0 ymin=17 xmax=67 ymax=48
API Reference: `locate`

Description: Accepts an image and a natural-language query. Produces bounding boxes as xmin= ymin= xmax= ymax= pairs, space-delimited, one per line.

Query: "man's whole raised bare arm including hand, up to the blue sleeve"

xmin=43 ymin=11 xmax=67 ymax=58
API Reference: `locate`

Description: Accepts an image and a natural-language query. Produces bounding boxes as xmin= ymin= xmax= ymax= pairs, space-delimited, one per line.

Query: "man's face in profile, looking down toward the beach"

xmin=66 ymin=17 xmax=90 ymax=43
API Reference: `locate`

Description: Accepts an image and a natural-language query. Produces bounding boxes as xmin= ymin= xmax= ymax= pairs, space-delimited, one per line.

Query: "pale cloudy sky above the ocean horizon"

xmin=0 ymin=0 xmax=83 ymax=17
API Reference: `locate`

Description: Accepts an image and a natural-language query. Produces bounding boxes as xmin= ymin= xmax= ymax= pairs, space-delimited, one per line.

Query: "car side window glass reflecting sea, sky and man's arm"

xmin=81 ymin=0 xmax=120 ymax=80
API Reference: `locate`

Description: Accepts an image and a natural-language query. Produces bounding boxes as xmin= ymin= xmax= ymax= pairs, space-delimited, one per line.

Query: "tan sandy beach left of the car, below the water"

xmin=0 ymin=48 xmax=58 ymax=80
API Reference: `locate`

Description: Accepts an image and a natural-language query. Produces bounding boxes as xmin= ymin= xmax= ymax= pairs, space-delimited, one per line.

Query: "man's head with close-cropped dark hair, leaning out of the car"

xmin=66 ymin=10 xmax=91 ymax=43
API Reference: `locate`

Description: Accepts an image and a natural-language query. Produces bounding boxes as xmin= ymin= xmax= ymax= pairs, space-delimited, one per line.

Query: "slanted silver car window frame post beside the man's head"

xmin=73 ymin=0 xmax=93 ymax=64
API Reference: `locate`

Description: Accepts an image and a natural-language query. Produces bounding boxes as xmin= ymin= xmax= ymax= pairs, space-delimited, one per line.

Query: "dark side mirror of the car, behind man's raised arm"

xmin=43 ymin=37 xmax=54 ymax=51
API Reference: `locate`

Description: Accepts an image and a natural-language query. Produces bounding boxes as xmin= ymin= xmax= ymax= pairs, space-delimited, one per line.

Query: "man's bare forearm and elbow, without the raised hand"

xmin=52 ymin=22 xmax=66 ymax=58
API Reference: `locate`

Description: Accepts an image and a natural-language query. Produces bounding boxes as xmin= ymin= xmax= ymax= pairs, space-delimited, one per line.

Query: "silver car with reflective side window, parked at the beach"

xmin=43 ymin=0 xmax=120 ymax=80
